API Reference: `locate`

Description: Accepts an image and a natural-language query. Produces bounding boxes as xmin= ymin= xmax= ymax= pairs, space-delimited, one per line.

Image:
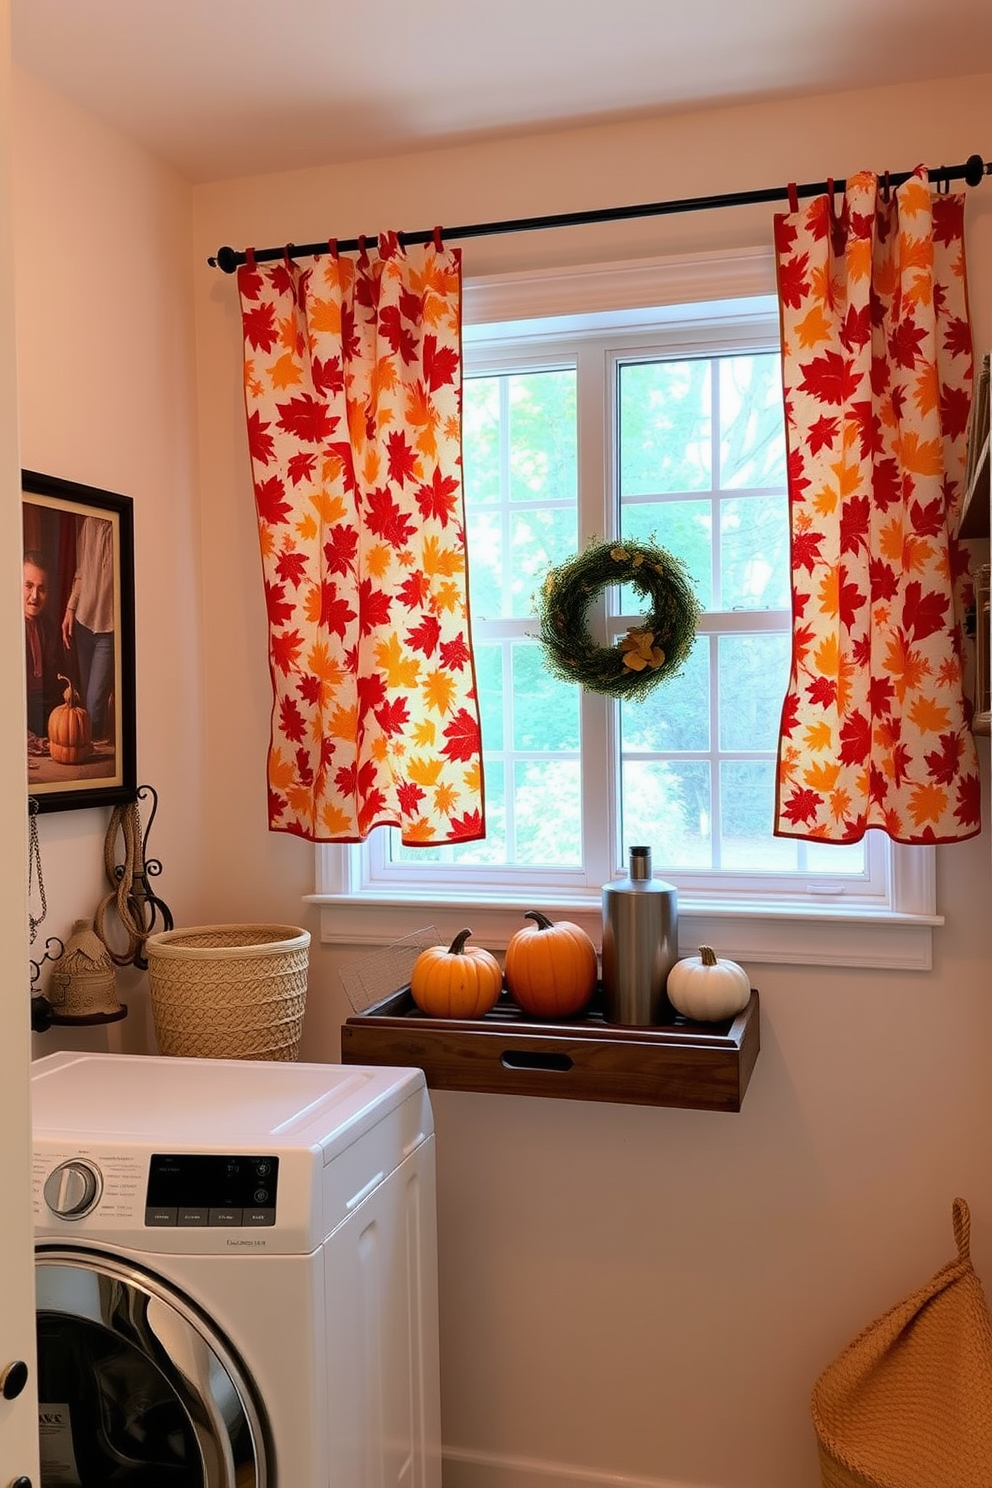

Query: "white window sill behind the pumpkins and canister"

xmin=306 ymin=890 xmax=943 ymax=972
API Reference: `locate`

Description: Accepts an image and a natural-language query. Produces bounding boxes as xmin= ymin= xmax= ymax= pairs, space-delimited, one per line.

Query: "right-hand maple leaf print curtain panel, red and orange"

xmin=775 ymin=170 xmax=982 ymax=842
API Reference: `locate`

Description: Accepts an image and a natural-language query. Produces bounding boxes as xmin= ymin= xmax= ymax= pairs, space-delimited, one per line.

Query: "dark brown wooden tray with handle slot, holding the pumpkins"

xmin=341 ymin=987 xmax=760 ymax=1112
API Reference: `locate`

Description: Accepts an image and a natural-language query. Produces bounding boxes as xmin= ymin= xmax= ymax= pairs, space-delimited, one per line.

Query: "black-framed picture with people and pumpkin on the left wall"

xmin=21 ymin=470 xmax=137 ymax=811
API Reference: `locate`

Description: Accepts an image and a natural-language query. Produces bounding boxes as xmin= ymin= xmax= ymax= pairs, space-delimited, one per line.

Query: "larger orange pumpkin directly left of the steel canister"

xmin=506 ymin=909 xmax=596 ymax=1018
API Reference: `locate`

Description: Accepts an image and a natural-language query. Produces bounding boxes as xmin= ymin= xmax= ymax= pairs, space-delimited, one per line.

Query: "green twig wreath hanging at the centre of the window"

xmin=540 ymin=542 xmax=699 ymax=699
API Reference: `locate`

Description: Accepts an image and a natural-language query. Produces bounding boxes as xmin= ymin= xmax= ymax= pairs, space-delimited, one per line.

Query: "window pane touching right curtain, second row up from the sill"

xmin=718 ymin=632 xmax=791 ymax=755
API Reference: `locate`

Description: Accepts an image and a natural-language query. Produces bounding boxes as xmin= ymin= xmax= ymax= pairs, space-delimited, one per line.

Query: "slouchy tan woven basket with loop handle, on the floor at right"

xmin=812 ymin=1199 xmax=992 ymax=1488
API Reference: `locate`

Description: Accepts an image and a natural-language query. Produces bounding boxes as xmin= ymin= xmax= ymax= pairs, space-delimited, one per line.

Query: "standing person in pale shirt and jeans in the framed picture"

xmin=62 ymin=516 xmax=115 ymax=743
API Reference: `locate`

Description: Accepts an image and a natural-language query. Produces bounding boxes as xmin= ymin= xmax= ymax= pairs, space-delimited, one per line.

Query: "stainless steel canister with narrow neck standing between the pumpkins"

xmin=602 ymin=847 xmax=678 ymax=1028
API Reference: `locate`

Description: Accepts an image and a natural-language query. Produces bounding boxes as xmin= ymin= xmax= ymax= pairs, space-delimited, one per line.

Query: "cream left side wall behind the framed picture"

xmin=13 ymin=70 xmax=205 ymax=1055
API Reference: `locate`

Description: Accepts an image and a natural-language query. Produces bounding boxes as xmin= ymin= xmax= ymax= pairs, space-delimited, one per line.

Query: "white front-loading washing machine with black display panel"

xmin=31 ymin=1054 xmax=440 ymax=1488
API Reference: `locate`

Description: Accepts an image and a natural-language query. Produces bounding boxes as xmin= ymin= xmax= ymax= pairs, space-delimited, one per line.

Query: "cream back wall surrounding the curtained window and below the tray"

xmin=193 ymin=76 xmax=992 ymax=1488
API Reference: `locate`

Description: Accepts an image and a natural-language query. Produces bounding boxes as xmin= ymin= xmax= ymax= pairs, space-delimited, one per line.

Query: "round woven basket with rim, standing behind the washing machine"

xmin=144 ymin=926 xmax=309 ymax=1059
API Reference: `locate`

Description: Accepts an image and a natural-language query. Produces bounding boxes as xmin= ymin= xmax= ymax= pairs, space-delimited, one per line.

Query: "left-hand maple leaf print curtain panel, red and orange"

xmin=238 ymin=235 xmax=485 ymax=845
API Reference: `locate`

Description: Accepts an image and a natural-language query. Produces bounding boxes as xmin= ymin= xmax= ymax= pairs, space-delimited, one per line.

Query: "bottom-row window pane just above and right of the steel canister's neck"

xmin=620 ymin=759 xmax=712 ymax=876
